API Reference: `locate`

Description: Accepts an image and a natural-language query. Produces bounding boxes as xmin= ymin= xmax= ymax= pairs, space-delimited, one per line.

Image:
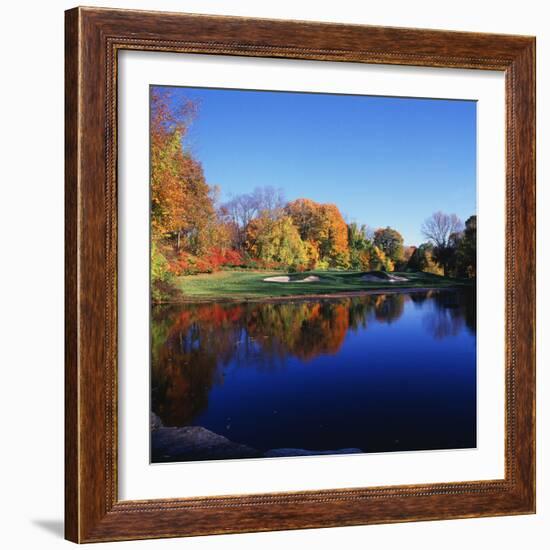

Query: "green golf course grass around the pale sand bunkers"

xmin=176 ymin=271 xmax=473 ymax=300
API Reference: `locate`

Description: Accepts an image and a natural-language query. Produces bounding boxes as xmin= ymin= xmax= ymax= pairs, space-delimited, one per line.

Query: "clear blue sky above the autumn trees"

xmin=152 ymin=88 xmax=476 ymax=244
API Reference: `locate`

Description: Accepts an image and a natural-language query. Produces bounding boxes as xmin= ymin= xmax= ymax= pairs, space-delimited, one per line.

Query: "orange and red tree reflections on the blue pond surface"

xmin=151 ymin=291 xmax=475 ymax=426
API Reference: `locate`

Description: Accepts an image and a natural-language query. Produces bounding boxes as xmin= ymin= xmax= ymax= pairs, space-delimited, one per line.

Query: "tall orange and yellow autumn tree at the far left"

xmin=150 ymin=89 xmax=230 ymax=300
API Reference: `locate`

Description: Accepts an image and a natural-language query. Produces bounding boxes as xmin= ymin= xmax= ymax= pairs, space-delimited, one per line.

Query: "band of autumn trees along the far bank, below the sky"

xmin=151 ymin=93 xmax=475 ymax=293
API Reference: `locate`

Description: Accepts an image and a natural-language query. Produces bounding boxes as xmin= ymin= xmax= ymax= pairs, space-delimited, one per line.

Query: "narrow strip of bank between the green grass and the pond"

xmin=151 ymin=285 xmax=468 ymax=306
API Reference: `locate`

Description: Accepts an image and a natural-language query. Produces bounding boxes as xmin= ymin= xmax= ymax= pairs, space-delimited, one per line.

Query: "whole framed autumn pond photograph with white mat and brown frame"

xmin=65 ymin=8 xmax=535 ymax=542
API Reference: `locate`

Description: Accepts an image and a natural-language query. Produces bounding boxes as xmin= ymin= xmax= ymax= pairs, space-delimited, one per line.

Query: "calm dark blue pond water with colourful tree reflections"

xmin=151 ymin=291 xmax=476 ymax=461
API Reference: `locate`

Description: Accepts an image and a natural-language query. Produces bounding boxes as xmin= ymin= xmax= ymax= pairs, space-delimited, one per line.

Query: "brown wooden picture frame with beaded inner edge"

xmin=65 ymin=8 xmax=535 ymax=542
